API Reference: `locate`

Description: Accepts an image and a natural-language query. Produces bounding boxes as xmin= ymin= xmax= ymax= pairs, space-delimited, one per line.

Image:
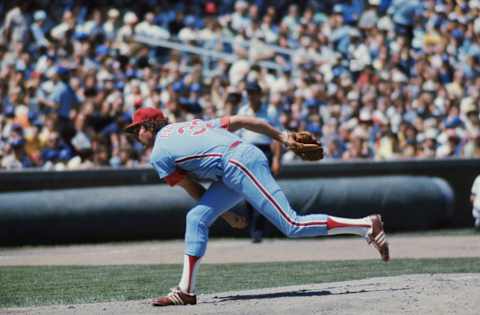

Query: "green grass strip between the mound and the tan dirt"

xmin=0 ymin=258 xmax=480 ymax=307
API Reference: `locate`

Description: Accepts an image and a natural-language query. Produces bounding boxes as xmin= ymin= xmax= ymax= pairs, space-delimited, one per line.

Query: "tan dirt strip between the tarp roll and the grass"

xmin=0 ymin=234 xmax=480 ymax=266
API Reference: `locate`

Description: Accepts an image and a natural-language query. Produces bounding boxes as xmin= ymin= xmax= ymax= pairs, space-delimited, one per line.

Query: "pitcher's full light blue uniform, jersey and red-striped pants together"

xmin=150 ymin=117 xmax=327 ymax=256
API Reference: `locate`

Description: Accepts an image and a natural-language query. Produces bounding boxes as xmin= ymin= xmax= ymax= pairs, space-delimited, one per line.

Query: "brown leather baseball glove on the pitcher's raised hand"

xmin=287 ymin=131 xmax=323 ymax=161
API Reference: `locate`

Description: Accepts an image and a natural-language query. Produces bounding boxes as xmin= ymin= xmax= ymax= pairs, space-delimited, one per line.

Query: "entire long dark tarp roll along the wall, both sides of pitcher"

xmin=0 ymin=176 xmax=453 ymax=245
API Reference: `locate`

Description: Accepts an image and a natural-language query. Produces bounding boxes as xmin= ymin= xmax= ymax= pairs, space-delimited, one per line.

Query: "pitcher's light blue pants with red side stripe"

xmin=185 ymin=144 xmax=328 ymax=257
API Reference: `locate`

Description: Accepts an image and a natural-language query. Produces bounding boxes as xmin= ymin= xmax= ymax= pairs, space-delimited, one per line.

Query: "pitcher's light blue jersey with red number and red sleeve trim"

xmin=150 ymin=117 xmax=240 ymax=186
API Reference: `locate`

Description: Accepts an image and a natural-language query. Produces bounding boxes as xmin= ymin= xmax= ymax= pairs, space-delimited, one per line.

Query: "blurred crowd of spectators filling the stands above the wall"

xmin=0 ymin=0 xmax=480 ymax=170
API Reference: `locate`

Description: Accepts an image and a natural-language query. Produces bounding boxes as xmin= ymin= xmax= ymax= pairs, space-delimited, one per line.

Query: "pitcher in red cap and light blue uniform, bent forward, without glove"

xmin=126 ymin=108 xmax=389 ymax=306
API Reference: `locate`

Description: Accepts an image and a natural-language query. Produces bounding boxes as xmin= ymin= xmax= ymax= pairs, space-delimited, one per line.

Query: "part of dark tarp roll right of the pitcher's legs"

xmin=282 ymin=176 xmax=454 ymax=231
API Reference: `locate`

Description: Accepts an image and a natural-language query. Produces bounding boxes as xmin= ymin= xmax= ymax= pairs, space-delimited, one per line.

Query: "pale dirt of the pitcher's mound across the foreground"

xmin=0 ymin=274 xmax=480 ymax=315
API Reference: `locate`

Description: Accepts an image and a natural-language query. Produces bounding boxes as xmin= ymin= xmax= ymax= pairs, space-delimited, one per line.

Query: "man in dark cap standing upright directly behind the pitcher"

xmin=238 ymin=81 xmax=282 ymax=243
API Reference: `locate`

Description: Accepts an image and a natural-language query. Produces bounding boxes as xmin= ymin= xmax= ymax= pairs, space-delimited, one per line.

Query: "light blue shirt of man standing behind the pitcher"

xmin=237 ymin=104 xmax=282 ymax=145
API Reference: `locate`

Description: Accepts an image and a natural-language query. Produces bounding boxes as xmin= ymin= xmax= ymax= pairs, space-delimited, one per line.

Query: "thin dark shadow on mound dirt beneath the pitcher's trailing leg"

xmin=213 ymin=287 xmax=410 ymax=303
